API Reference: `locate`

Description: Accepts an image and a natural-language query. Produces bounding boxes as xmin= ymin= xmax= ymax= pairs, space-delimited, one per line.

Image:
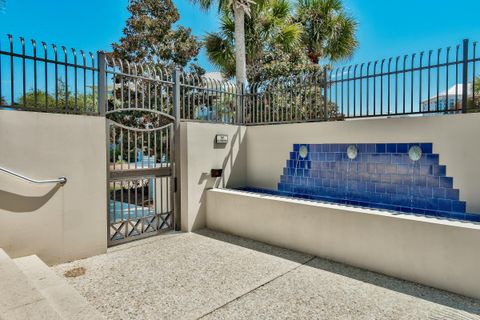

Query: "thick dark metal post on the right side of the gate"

xmin=170 ymin=68 xmax=182 ymax=230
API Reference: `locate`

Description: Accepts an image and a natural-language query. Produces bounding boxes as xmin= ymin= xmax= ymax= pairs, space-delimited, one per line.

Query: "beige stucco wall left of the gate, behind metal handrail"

xmin=0 ymin=110 xmax=107 ymax=264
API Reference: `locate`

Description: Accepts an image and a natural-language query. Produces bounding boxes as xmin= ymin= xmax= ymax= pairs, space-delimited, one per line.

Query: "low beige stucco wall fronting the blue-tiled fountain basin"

xmin=207 ymin=189 xmax=480 ymax=298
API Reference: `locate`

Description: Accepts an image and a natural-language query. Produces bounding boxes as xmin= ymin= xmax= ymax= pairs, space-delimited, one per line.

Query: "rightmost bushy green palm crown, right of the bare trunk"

xmin=296 ymin=0 xmax=358 ymax=64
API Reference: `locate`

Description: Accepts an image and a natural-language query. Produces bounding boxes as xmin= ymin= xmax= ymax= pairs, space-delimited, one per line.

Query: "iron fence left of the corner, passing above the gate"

xmin=0 ymin=35 xmax=240 ymax=123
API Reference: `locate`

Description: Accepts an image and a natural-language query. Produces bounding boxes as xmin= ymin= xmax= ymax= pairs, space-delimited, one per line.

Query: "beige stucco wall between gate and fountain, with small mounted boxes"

xmin=180 ymin=122 xmax=246 ymax=231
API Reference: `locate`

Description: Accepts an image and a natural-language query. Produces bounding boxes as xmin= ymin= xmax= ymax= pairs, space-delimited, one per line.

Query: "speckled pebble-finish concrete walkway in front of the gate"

xmin=54 ymin=230 xmax=480 ymax=319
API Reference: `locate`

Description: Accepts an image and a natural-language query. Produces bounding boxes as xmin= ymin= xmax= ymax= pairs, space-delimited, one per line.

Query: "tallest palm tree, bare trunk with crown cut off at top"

xmin=192 ymin=0 xmax=254 ymax=86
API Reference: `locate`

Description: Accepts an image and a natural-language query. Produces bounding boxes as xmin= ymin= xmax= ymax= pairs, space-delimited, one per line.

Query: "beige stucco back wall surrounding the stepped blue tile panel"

xmin=246 ymin=114 xmax=480 ymax=213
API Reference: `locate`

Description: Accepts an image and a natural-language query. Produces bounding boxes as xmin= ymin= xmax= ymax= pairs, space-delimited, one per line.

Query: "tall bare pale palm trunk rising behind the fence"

xmin=233 ymin=6 xmax=247 ymax=86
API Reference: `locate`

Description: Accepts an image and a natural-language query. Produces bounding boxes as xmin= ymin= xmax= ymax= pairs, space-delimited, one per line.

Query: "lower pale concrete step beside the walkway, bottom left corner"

xmin=14 ymin=255 xmax=105 ymax=320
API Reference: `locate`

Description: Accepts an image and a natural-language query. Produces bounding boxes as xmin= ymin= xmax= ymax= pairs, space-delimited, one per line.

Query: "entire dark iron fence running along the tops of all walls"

xmin=0 ymin=35 xmax=480 ymax=125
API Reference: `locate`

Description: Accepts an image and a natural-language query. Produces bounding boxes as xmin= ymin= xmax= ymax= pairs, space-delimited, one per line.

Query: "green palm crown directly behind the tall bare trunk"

xmin=205 ymin=0 xmax=301 ymax=82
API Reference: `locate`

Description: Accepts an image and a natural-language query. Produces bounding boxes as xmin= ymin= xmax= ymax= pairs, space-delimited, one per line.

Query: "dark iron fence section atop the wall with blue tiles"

xmin=244 ymin=40 xmax=480 ymax=124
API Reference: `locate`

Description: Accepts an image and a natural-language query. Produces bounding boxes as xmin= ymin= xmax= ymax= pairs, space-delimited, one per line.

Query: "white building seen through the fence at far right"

xmin=422 ymin=83 xmax=472 ymax=111
